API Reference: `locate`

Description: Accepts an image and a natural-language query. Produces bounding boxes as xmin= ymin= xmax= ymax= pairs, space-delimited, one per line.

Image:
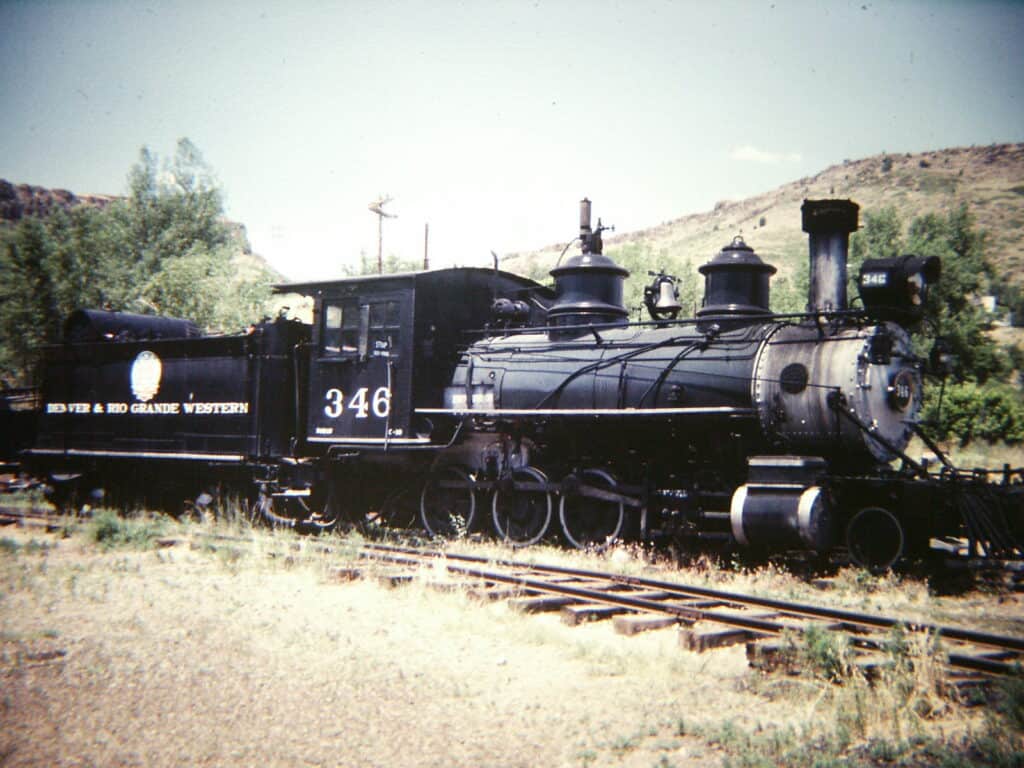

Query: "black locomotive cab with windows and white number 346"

xmin=276 ymin=267 xmax=544 ymax=451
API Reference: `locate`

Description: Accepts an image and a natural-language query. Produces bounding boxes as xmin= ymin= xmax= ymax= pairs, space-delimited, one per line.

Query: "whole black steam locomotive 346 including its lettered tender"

xmin=6 ymin=200 xmax=1022 ymax=568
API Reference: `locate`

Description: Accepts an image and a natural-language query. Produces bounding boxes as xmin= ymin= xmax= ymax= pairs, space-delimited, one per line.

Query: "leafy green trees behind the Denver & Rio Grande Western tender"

xmin=0 ymin=139 xmax=271 ymax=384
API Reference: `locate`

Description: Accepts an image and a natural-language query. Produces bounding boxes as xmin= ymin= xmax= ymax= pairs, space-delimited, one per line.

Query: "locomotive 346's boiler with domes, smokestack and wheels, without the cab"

xmin=411 ymin=201 xmax=962 ymax=565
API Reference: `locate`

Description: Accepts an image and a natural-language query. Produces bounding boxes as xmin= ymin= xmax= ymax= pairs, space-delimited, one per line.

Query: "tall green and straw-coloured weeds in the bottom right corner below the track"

xmin=708 ymin=627 xmax=987 ymax=768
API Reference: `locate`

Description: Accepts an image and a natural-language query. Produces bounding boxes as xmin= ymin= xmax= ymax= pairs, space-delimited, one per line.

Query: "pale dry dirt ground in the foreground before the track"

xmin=0 ymin=528 xmax=1021 ymax=767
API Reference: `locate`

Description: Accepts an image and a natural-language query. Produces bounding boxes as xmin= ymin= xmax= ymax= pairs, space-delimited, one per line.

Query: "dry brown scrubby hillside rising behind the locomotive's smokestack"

xmin=503 ymin=143 xmax=1024 ymax=292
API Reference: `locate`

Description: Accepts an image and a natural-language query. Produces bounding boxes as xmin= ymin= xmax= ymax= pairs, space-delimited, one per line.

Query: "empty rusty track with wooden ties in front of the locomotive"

xmin=0 ymin=507 xmax=1024 ymax=675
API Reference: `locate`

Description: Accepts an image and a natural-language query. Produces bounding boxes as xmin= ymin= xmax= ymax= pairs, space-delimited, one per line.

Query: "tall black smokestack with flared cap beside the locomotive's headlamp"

xmin=800 ymin=200 xmax=860 ymax=312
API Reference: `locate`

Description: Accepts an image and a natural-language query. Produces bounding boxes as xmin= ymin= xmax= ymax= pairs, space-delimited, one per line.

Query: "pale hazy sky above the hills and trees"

xmin=0 ymin=0 xmax=1024 ymax=280
